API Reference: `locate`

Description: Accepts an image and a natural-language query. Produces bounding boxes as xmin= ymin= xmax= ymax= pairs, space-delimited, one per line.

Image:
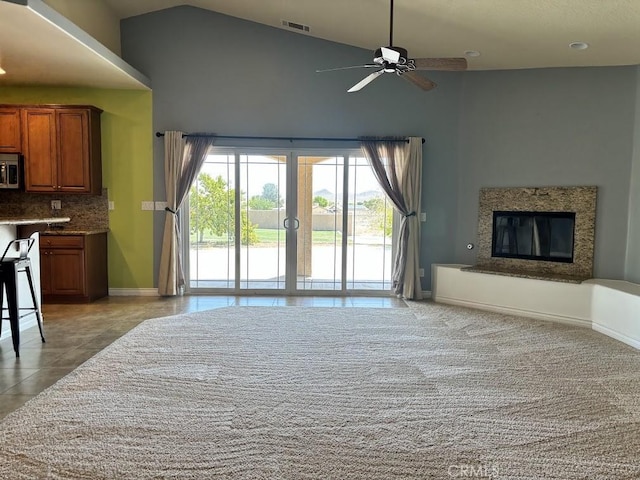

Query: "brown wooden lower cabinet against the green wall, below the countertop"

xmin=40 ymin=233 xmax=108 ymax=303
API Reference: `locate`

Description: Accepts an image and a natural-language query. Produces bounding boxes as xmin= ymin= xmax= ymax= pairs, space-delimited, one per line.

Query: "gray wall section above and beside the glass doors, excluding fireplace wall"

xmin=121 ymin=7 xmax=462 ymax=288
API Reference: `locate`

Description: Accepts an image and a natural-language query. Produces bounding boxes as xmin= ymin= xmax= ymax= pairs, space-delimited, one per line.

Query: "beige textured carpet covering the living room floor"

xmin=0 ymin=302 xmax=640 ymax=480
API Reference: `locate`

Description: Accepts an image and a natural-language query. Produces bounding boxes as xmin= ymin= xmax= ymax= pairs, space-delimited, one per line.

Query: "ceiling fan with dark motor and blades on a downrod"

xmin=316 ymin=0 xmax=467 ymax=93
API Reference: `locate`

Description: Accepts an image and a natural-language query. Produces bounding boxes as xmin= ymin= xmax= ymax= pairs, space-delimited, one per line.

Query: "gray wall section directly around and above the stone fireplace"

xmin=455 ymin=67 xmax=636 ymax=279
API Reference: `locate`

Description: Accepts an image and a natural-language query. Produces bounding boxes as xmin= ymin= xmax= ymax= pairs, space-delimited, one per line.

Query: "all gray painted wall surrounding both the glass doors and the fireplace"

xmin=121 ymin=7 xmax=640 ymax=289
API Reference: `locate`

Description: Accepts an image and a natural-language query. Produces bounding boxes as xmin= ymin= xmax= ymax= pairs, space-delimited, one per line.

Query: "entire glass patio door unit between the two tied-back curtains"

xmin=184 ymin=149 xmax=393 ymax=295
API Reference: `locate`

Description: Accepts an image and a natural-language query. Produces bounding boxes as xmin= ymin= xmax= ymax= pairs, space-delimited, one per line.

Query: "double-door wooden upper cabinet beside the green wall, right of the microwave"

xmin=21 ymin=106 xmax=102 ymax=195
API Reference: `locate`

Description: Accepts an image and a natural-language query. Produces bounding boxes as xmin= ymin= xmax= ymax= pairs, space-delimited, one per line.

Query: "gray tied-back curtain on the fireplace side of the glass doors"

xmin=361 ymin=137 xmax=422 ymax=300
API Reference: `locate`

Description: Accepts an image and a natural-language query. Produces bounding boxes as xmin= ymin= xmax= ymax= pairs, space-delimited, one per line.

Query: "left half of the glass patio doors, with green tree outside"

xmin=185 ymin=152 xmax=287 ymax=291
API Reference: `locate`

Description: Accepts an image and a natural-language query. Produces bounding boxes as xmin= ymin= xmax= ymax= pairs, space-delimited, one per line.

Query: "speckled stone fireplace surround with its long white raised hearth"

xmin=431 ymin=187 xmax=640 ymax=350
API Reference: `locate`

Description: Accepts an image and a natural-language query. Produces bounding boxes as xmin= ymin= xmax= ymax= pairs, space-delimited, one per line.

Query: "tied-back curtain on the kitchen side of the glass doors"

xmin=158 ymin=131 xmax=215 ymax=296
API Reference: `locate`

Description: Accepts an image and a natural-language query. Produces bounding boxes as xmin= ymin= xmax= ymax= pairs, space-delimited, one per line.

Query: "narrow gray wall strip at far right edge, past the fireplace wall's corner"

xmin=625 ymin=67 xmax=640 ymax=283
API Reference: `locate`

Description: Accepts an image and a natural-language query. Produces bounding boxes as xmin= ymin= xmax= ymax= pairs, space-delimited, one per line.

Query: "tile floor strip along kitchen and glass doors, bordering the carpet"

xmin=0 ymin=295 xmax=406 ymax=419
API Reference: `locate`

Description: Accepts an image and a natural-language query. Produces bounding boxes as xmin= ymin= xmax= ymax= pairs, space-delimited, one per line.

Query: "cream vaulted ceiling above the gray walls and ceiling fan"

xmin=105 ymin=0 xmax=640 ymax=70
